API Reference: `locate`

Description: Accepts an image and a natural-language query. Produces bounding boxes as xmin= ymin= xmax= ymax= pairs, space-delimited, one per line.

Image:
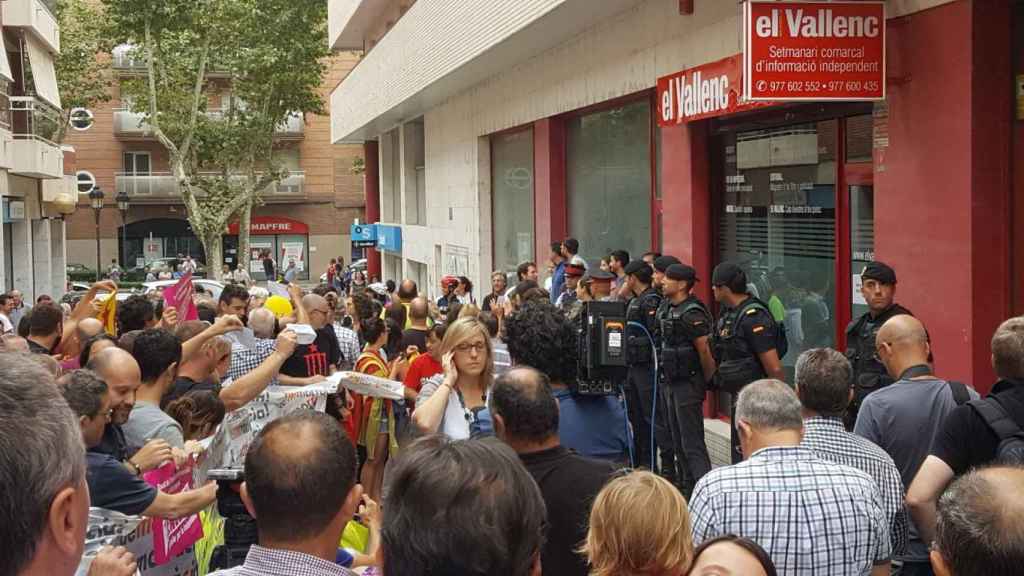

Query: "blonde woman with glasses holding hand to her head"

xmin=413 ymin=318 xmax=495 ymax=440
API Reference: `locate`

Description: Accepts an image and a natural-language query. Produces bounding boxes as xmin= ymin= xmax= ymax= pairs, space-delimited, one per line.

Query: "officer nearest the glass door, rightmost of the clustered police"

xmin=712 ymin=262 xmax=785 ymax=463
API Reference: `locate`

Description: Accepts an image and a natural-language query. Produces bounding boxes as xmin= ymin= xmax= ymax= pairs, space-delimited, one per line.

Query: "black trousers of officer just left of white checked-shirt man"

xmin=662 ymin=382 xmax=711 ymax=498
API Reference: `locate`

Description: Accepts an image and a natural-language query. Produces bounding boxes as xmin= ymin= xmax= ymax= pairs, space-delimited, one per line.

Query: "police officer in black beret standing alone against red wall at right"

xmin=844 ymin=261 xmax=913 ymax=429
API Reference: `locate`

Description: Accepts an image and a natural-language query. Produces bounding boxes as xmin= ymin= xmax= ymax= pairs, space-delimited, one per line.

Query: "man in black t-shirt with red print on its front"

xmin=281 ymin=294 xmax=342 ymax=379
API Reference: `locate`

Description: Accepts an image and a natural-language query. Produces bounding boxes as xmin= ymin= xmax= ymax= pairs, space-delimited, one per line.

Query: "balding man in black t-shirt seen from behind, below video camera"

xmin=488 ymin=367 xmax=614 ymax=576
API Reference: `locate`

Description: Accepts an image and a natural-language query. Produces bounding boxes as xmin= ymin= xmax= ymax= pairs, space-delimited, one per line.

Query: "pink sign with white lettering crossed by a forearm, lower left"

xmin=142 ymin=461 xmax=203 ymax=565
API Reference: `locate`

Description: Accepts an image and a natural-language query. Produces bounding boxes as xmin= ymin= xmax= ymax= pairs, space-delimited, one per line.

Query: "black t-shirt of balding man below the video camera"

xmin=519 ymin=446 xmax=615 ymax=576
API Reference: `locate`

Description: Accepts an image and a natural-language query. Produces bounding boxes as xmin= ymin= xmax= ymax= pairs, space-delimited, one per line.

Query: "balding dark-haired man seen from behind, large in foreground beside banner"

xmin=213 ymin=410 xmax=362 ymax=576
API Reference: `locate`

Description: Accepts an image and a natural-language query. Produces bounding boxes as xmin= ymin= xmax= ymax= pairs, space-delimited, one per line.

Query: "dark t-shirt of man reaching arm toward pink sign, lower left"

xmin=85 ymin=452 xmax=157 ymax=516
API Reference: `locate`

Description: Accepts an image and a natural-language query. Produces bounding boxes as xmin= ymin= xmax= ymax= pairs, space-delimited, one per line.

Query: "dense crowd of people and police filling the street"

xmin=0 ymin=234 xmax=1024 ymax=576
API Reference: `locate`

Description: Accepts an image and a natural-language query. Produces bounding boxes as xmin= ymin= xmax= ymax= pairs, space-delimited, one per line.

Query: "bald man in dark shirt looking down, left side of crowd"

xmin=88 ymin=347 xmax=171 ymax=476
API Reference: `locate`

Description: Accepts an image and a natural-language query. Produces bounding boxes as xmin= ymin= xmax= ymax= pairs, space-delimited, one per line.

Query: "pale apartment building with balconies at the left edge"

xmin=0 ymin=0 xmax=75 ymax=300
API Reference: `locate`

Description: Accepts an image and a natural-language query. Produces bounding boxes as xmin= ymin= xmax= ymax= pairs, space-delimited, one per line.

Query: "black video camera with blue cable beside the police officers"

xmin=572 ymin=301 xmax=627 ymax=396
